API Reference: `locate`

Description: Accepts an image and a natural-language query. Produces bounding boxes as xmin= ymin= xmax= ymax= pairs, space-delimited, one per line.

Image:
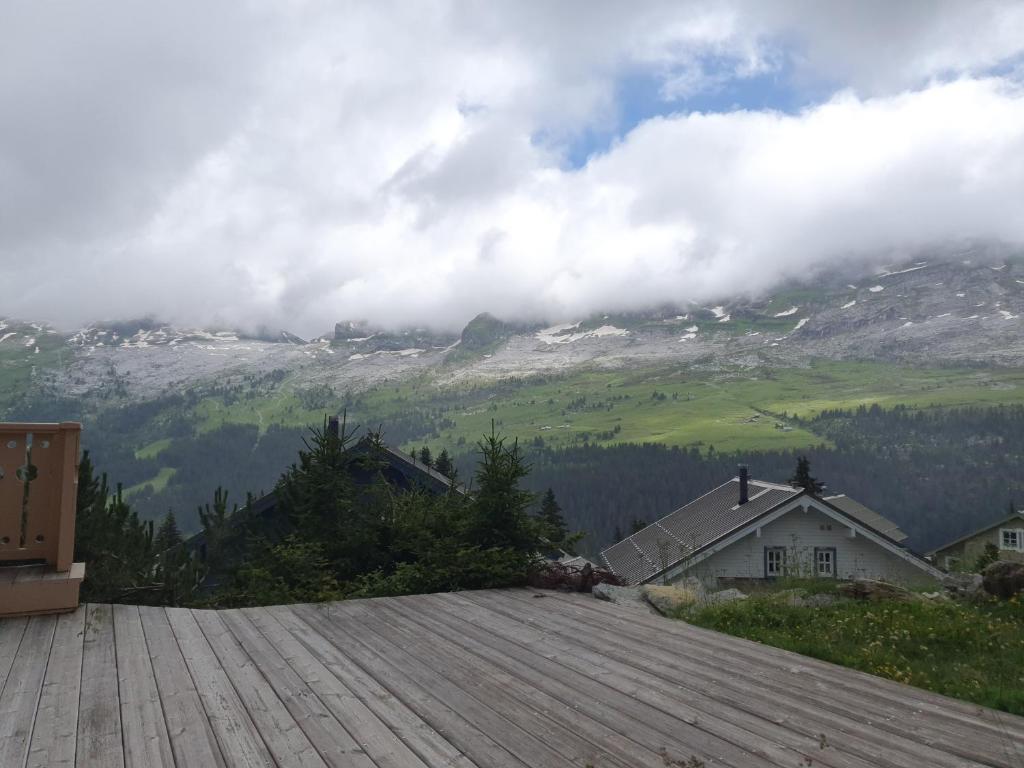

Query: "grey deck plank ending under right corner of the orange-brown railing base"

xmin=28 ymin=608 xmax=85 ymax=768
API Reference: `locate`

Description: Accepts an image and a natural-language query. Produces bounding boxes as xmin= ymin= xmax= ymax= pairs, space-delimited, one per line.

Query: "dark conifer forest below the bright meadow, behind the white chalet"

xmin=512 ymin=406 xmax=1024 ymax=551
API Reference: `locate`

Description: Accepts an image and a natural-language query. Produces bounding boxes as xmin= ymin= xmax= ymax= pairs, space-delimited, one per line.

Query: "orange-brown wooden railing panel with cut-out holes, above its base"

xmin=0 ymin=422 xmax=82 ymax=571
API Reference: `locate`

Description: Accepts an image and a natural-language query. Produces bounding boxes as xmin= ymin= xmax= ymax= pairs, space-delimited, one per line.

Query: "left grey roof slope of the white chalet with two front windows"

xmin=601 ymin=477 xmax=804 ymax=584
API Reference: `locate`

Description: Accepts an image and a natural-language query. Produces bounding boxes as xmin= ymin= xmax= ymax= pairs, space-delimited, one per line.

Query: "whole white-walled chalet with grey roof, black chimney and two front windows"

xmin=601 ymin=467 xmax=942 ymax=584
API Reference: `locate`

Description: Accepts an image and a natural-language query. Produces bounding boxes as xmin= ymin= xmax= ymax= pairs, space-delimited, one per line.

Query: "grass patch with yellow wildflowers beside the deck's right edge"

xmin=686 ymin=594 xmax=1024 ymax=715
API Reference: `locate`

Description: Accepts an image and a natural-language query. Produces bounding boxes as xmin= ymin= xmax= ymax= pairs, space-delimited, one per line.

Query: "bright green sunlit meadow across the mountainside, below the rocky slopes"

xmin=350 ymin=360 xmax=1024 ymax=453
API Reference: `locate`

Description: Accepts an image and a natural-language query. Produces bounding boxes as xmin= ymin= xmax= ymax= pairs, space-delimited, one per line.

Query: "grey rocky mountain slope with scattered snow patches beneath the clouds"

xmin=8 ymin=259 xmax=1024 ymax=405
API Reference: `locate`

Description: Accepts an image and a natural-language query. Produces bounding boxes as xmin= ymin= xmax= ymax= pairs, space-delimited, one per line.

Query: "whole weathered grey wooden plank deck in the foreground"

xmin=0 ymin=590 xmax=1024 ymax=768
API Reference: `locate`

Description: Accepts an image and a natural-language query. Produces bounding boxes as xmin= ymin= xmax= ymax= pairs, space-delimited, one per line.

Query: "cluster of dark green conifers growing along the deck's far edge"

xmin=76 ymin=426 xmax=577 ymax=606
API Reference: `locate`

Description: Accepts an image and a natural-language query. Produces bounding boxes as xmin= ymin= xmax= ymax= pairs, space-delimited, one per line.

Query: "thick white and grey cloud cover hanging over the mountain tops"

xmin=0 ymin=0 xmax=1024 ymax=334
